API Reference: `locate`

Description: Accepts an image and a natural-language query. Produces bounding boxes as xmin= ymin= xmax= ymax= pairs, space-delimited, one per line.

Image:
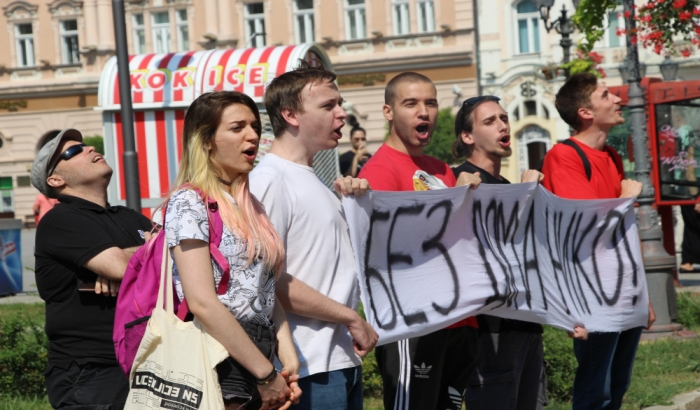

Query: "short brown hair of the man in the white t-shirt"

xmin=263 ymin=60 xmax=336 ymax=137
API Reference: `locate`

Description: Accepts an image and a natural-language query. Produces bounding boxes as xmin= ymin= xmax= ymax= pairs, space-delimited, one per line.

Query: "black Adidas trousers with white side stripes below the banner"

xmin=375 ymin=326 xmax=479 ymax=410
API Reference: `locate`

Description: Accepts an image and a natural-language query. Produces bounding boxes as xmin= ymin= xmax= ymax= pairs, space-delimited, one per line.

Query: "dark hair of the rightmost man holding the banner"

xmin=554 ymin=73 xmax=598 ymax=131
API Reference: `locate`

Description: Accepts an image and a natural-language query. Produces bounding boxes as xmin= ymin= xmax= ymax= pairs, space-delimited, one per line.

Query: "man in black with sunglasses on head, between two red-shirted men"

xmin=452 ymin=96 xmax=547 ymax=410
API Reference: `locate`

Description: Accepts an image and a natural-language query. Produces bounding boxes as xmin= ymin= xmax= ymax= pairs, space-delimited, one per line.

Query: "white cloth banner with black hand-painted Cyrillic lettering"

xmin=343 ymin=183 xmax=649 ymax=344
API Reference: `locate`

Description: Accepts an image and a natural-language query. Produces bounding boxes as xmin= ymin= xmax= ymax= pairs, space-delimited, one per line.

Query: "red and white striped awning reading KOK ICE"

xmin=98 ymin=44 xmax=333 ymax=111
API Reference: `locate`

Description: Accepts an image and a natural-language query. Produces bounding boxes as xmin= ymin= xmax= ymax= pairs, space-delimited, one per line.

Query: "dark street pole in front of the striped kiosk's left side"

xmin=112 ymin=0 xmax=141 ymax=212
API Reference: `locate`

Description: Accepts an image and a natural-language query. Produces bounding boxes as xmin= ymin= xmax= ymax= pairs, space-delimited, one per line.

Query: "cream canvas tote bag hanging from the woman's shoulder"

xmin=124 ymin=237 xmax=228 ymax=410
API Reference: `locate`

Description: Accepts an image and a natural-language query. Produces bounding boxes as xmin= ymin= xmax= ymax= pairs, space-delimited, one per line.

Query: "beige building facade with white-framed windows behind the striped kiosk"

xmin=0 ymin=0 xmax=477 ymax=223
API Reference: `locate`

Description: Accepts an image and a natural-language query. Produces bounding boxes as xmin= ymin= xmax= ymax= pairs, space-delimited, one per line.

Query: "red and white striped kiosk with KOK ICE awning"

xmin=97 ymin=44 xmax=340 ymax=218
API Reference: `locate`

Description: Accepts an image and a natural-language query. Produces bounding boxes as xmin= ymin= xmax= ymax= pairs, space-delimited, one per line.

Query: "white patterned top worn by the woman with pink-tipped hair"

xmin=165 ymin=189 xmax=275 ymax=325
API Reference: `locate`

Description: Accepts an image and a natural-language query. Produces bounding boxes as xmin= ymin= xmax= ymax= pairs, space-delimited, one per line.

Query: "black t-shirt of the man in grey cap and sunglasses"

xmin=34 ymin=195 xmax=152 ymax=366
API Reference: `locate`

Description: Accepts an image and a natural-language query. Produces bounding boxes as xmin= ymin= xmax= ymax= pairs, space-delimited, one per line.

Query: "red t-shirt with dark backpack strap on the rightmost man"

xmin=542 ymin=138 xmax=624 ymax=199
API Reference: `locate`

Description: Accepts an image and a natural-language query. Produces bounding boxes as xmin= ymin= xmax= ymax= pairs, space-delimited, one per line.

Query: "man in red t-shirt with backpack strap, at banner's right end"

xmin=542 ymin=73 xmax=656 ymax=410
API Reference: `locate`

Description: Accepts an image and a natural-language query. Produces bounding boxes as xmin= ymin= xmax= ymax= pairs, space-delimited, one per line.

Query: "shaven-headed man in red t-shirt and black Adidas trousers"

xmin=359 ymin=72 xmax=481 ymax=410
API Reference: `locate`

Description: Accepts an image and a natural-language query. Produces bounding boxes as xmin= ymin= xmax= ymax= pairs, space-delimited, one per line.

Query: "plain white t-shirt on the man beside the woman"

xmin=250 ymin=153 xmax=361 ymax=377
